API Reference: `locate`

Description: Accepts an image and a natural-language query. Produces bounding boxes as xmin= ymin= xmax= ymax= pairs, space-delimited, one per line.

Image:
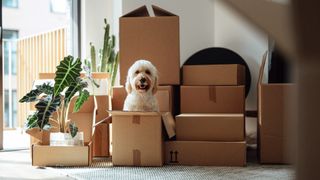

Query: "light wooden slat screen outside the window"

xmin=17 ymin=28 xmax=67 ymax=127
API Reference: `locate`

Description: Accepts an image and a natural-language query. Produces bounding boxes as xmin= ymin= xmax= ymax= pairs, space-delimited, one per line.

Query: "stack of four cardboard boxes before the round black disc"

xmin=165 ymin=64 xmax=246 ymax=166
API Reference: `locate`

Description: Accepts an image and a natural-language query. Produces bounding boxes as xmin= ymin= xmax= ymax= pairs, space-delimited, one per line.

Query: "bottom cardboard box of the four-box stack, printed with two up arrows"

xmin=165 ymin=141 xmax=246 ymax=166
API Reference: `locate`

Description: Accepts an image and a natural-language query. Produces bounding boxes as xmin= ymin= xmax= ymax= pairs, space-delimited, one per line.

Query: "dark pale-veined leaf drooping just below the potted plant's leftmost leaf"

xmin=35 ymin=95 xmax=61 ymax=129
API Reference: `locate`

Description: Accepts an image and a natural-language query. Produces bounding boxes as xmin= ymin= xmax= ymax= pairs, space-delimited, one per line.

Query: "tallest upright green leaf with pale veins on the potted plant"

xmin=54 ymin=56 xmax=82 ymax=96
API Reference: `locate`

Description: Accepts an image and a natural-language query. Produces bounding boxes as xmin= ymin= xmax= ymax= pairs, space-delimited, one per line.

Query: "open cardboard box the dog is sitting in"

xmin=111 ymin=111 xmax=164 ymax=166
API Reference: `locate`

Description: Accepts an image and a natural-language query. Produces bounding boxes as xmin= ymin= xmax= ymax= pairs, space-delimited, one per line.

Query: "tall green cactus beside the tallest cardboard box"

xmin=84 ymin=19 xmax=119 ymax=95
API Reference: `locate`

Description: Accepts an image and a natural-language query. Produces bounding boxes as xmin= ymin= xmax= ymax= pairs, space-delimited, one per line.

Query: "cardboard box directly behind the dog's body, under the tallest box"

xmin=112 ymin=86 xmax=175 ymax=113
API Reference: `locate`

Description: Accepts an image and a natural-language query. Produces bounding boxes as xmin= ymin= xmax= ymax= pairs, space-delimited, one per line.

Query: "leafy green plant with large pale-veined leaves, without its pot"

xmin=19 ymin=56 xmax=89 ymax=141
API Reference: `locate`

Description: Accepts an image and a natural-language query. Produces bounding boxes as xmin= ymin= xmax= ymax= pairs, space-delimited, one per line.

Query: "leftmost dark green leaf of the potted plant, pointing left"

xmin=19 ymin=83 xmax=53 ymax=103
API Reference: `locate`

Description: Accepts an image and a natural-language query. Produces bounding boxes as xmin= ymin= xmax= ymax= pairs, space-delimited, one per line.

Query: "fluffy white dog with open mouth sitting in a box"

xmin=123 ymin=60 xmax=159 ymax=111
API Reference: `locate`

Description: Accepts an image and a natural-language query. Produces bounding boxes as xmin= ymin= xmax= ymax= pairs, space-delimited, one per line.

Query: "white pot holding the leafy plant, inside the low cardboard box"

xmin=50 ymin=132 xmax=84 ymax=146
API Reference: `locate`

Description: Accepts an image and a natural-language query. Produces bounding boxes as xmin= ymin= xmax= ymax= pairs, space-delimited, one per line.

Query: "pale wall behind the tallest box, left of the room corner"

xmin=122 ymin=0 xmax=214 ymax=65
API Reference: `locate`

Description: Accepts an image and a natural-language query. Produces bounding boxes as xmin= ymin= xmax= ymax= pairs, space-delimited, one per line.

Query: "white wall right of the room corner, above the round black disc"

xmin=214 ymin=0 xmax=268 ymax=110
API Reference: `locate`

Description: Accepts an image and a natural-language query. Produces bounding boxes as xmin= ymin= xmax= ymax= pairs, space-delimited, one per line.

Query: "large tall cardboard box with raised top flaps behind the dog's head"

xmin=119 ymin=6 xmax=180 ymax=85
